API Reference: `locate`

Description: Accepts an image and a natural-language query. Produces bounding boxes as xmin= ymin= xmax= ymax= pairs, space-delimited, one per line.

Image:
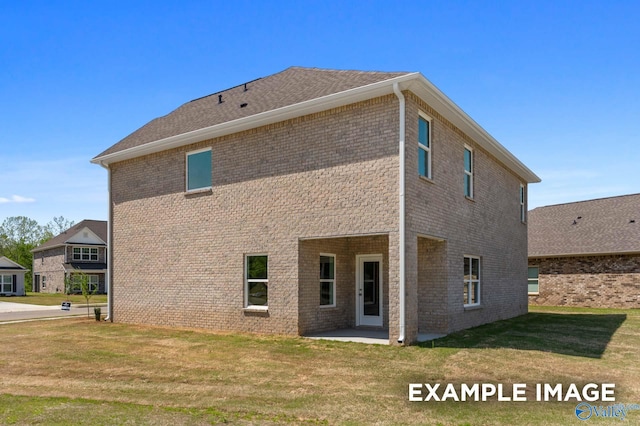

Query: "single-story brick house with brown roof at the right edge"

xmin=529 ymin=194 xmax=640 ymax=308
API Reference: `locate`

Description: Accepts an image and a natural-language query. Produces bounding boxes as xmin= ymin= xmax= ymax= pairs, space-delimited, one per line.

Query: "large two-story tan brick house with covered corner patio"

xmin=92 ymin=67 xmax=539 ymax=343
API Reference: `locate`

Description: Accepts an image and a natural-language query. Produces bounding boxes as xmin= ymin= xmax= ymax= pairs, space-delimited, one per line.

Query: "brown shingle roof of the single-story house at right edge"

xmin=528 ymin=194 xmax=640 ymax=257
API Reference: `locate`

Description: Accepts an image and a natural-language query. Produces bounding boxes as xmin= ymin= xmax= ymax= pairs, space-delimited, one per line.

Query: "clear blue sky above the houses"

xmin=0 ymin=0 xmax=640 ymax=224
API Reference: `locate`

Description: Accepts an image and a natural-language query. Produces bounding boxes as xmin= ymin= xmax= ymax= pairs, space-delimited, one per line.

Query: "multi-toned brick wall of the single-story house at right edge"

xmin=529 ymin=255 xmax=640 ymax=308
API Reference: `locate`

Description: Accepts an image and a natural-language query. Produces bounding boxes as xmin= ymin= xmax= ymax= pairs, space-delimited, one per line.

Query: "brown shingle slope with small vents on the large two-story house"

xmin=96 ymin=67 xmax=408 ymax=158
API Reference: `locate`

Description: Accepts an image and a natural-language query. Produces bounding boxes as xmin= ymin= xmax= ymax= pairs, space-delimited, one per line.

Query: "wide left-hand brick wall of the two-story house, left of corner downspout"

xmin=111 ymin=95 xmax=398 ymax=334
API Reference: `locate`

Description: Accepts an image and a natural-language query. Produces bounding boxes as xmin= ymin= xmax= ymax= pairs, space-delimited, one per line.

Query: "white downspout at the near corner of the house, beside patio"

xmin=393 ymin=82 xmax=406 ymax=343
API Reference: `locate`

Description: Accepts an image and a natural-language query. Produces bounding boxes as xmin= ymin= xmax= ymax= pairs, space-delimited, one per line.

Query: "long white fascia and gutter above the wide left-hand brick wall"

xmin=91 ymin=73 xmax=420 ymax=166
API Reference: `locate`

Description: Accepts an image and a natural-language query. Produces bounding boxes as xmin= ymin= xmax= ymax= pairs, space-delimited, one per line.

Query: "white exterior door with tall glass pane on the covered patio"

xmin=356 ymin=254 xmax=383 ymax=327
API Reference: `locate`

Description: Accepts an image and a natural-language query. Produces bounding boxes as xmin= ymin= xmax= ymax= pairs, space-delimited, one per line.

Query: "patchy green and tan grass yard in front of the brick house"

xmin=0 ymin=308 xmax=640 ymax=425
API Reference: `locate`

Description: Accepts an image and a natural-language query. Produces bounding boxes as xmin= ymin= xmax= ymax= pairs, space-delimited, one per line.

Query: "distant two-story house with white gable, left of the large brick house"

xmin=31 ymin=220 xmax=107 ymax=293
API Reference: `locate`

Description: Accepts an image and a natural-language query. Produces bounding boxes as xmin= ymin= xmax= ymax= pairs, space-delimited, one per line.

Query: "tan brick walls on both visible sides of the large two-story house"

xmin=111 ymin=92 xmax=527 ymax=343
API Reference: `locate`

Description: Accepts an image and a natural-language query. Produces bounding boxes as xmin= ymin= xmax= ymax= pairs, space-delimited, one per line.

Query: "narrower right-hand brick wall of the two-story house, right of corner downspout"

xmin=404 ymin=94 xmax=527 ymax=332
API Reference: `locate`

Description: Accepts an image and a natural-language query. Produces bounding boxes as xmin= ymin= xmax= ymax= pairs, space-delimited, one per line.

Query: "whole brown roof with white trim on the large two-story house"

xmin=91 ymin=67 xmax=540 ymax=183
